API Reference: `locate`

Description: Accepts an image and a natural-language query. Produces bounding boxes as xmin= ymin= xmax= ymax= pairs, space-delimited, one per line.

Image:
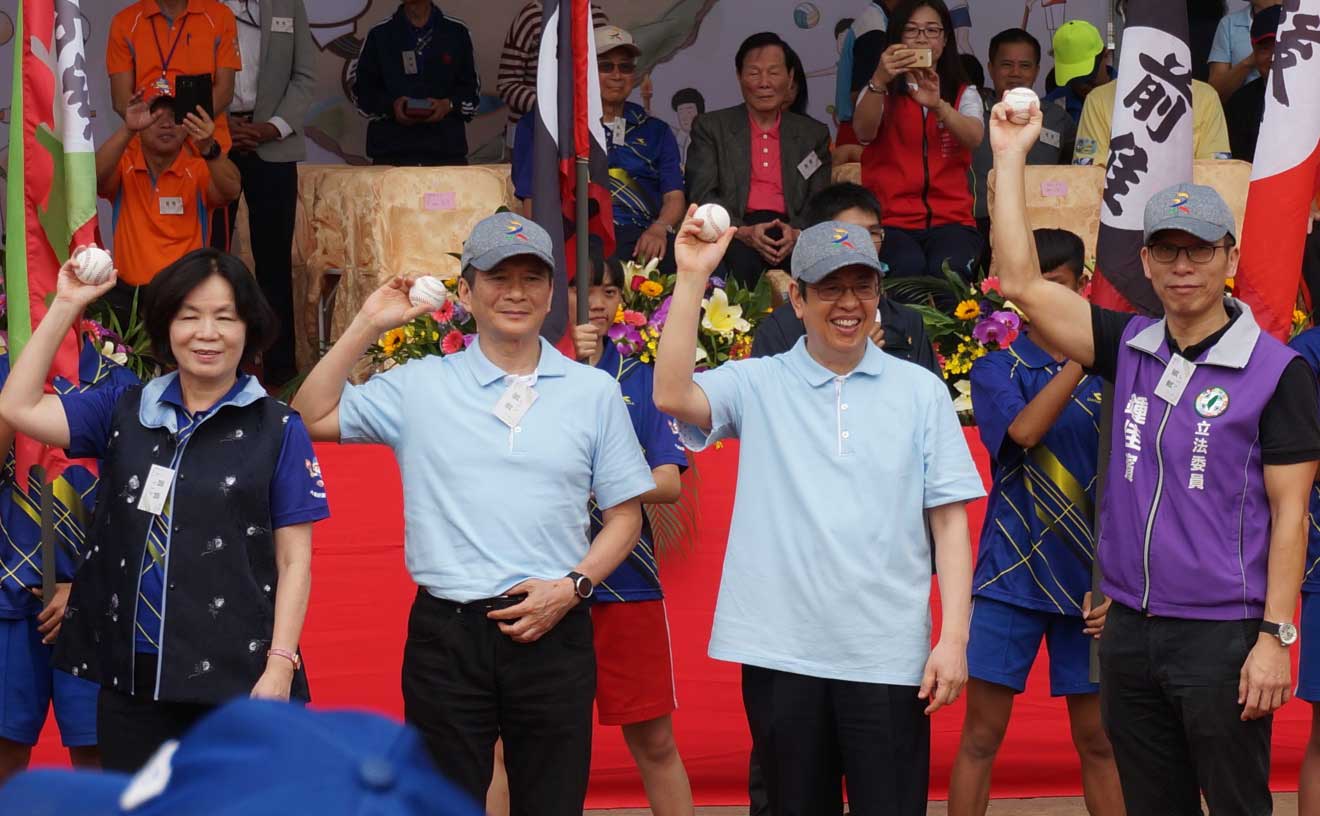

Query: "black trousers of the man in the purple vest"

xmin=1100 ymin=602 xmax=1274 ymax=816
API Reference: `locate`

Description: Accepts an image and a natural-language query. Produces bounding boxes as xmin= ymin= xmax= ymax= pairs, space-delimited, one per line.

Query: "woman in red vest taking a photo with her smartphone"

xmin=853 ymin=0 xmax=985 ymax=286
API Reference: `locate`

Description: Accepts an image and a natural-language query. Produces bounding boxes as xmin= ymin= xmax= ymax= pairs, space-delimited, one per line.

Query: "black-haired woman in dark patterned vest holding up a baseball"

xmin=0 ymin=250 xmax=329 ymax=771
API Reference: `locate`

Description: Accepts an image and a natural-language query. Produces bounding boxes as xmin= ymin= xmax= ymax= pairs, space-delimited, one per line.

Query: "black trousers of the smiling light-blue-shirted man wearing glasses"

xmin=742 ymin=665 xmax=931 ymax=816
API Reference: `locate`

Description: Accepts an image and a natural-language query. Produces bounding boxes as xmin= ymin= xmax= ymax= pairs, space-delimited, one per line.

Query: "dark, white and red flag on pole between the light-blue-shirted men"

xmin=532 ymin=0 xmax=614 ymax=343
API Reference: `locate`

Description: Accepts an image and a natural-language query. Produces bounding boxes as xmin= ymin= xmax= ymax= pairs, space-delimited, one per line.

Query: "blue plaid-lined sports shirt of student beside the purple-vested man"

xmin=972 ymin=334 xmax=1102 ymax=615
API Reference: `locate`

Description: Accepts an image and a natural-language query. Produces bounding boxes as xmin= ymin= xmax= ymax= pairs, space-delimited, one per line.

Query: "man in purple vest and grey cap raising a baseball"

xmin=990 ymin=95 xmax=1320 ymax=816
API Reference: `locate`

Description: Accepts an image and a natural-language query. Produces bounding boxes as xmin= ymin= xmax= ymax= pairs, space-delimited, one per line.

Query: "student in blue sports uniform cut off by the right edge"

xmin=1288 ymin=327 xmax=1320 ymax=816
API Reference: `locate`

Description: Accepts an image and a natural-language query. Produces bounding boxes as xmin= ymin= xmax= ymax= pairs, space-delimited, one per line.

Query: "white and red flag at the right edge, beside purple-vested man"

xmin=1234 ymin=0 xmax=1320 ymax=339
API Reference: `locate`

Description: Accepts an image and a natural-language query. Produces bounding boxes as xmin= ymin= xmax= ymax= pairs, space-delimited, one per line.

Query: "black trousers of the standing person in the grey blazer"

xmin=211 ymin=151 xmax=298 ymax=386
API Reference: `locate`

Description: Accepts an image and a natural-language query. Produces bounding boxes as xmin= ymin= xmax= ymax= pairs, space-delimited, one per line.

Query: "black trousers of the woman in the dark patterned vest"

xmin=96 ymin=655 xmax=215 ymax=774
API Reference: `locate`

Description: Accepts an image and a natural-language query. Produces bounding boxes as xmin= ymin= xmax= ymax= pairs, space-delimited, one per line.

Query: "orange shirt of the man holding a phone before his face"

xmin=100 ymin=137 xmax=224 ymax=287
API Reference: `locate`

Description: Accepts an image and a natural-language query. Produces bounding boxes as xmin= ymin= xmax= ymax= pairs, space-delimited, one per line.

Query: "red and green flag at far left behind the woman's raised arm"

xmin=5 ymin=0 xmax=96 ymax=591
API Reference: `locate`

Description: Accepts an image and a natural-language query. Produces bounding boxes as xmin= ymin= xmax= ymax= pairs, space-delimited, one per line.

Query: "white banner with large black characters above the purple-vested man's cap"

xmin=1092 ymin=0 xmax=1192 ymax=314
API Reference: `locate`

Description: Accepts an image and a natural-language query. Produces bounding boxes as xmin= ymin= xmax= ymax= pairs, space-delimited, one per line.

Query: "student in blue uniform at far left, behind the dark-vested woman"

xmin=0 ymin=331 xmax=137 ymax=783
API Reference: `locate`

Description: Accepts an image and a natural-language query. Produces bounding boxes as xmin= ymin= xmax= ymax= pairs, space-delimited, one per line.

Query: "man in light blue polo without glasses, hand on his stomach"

xmin=294 ymin=213 xmax=655 ymax=816
